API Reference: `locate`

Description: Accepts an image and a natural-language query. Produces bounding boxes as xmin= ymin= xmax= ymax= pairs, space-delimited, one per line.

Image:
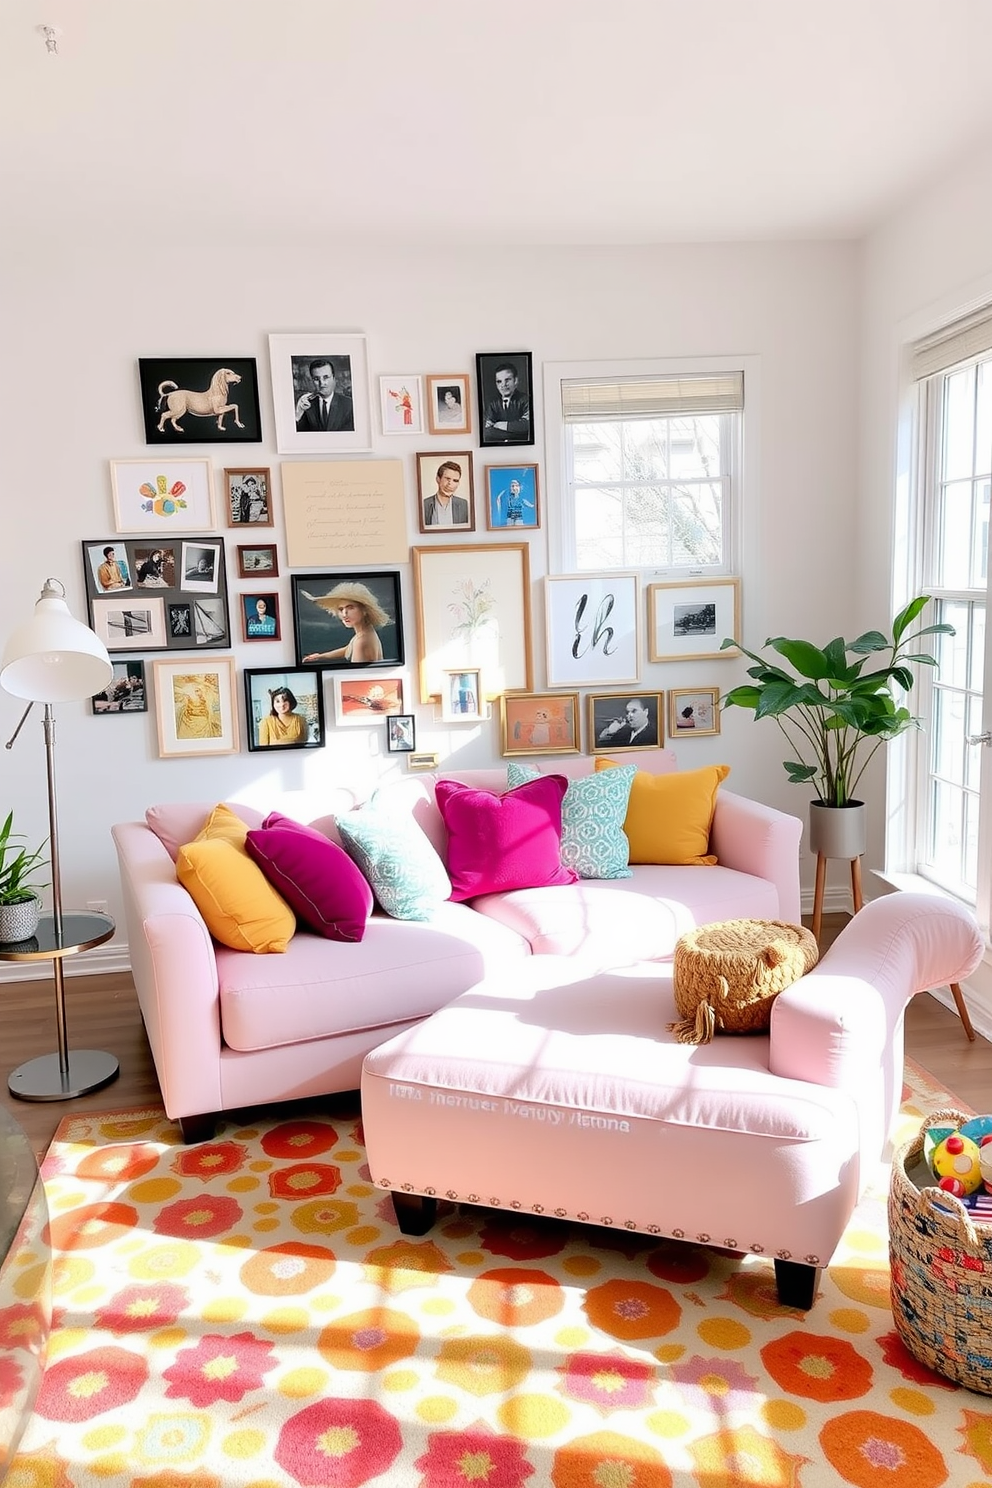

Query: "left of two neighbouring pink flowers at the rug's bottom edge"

xmin=274 ymin=1400 xmax=403 ymax=1488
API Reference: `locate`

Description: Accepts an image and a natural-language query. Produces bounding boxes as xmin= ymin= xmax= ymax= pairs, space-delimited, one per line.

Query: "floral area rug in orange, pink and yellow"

xmin=0 ymin=1067 xmax=992 ymax=1488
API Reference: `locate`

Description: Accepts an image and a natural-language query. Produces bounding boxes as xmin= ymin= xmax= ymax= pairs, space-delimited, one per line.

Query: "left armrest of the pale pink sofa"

xmin=112 ymin=821 xmax=223 ymax=1119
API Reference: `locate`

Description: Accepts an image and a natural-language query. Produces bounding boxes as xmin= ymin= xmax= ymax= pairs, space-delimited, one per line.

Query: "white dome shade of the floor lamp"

xmin=0 ymin=579 xmax=113 ymax=702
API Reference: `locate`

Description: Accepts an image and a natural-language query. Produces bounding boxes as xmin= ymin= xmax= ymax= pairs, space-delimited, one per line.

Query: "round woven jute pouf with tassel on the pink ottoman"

xmin=668 ymin=920 xmax=819 ymax=1043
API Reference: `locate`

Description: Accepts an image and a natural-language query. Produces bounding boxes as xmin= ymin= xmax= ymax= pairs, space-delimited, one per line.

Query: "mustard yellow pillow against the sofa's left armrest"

xmin=175 ymin=838 xmax=296 ymax=954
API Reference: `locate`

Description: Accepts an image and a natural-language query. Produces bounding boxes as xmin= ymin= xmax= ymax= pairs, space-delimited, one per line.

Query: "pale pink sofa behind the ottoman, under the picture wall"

xmin=113 ymin=750 xmax=802 ymax=1140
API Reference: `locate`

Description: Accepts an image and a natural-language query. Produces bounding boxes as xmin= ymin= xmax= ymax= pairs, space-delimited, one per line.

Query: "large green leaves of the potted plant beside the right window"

xmin=720 ymin=594 xmax=955 ymax=806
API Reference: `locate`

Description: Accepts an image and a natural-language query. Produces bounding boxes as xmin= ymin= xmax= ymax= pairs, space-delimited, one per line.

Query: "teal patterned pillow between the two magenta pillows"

xmin=336 ymin=803 xmax=452 ymax=920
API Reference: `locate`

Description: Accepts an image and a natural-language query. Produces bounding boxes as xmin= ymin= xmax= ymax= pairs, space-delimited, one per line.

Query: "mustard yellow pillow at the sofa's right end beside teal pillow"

xmin=596 ymin=759 xmax=730 ymax=863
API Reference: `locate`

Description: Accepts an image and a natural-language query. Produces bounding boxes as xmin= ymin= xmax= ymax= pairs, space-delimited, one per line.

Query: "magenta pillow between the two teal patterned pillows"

xmin=434 ymin=775 xmax=579 ymax=900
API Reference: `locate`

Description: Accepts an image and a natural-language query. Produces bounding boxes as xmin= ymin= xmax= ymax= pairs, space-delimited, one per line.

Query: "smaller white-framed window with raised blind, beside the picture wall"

xmin=546 ymin=363 xmax=744 ymax=574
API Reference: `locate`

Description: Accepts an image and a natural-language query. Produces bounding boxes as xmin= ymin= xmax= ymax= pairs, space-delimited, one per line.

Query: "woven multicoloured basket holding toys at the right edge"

xmin=888 ymin=1110 xmax=992 ymax=1394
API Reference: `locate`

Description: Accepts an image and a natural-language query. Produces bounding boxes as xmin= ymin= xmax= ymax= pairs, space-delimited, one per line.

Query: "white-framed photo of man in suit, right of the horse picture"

xmin=269 ymin=330 xmax=372 ymax=455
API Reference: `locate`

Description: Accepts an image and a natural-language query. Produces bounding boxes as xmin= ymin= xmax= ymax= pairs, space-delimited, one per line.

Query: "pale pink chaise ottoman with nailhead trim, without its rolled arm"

xmin=361 ymin=957 xmax=861 ymax=1308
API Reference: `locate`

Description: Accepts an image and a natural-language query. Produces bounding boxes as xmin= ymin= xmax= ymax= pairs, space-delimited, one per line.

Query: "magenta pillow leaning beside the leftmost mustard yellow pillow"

xmin=245 ymin=817 xmax=372 ymax=940
